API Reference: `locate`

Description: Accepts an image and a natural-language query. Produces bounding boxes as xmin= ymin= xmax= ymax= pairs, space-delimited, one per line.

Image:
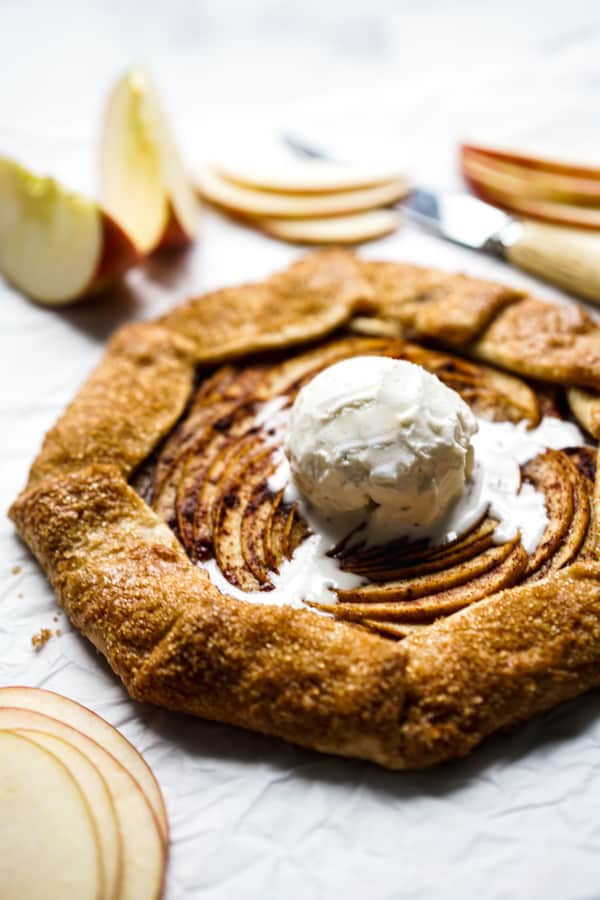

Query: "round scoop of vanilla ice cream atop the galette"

xmin=285 ymin=356 xmax=477 ymax=532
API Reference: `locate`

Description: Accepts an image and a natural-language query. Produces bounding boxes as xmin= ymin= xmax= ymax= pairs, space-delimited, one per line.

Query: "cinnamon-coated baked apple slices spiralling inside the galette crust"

xmin=135 ymin=337 xmax=595 ymax=637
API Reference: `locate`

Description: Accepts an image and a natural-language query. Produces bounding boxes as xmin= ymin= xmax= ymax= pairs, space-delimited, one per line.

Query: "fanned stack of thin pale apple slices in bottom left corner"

xmin=0 ymin=687 xmax=168 ymax=900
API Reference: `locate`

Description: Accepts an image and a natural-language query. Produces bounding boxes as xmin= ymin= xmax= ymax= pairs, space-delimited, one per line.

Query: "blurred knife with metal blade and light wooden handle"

xmin=283 ymin=134 xmax=600 ymax=304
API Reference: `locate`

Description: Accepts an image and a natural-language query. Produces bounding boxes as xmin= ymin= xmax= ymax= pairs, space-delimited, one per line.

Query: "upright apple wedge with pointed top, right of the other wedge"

xmin=100 ymin=68 xmax=199 ymax=254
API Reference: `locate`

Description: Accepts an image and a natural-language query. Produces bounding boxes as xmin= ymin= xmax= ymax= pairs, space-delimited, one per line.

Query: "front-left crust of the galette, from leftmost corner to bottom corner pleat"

xmin=11 ymin=466 xmax=405 ymax=762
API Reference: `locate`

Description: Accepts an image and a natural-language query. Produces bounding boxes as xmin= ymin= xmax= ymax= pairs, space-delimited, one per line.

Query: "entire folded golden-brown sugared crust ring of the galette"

xmin=11 ymin=251 xmax=600 ymax=768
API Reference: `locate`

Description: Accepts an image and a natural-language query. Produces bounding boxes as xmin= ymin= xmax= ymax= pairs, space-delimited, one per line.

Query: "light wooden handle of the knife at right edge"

xmin=504 ymin=220 xmax=600 ymax=304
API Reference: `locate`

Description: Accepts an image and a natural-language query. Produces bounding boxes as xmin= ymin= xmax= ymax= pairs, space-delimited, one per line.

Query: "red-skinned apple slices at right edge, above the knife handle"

xmin=461 ymin=144 xmax=600 ymax=231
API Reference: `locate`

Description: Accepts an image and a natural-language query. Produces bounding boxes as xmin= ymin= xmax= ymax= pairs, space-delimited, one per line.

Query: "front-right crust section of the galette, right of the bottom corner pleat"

xmin=403 ymin=563 xmax=600 ymax=766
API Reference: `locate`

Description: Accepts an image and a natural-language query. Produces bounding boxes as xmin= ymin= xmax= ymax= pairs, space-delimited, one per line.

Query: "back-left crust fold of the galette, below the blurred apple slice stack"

xmin=160 ymin=250 xmax=371 ymax=362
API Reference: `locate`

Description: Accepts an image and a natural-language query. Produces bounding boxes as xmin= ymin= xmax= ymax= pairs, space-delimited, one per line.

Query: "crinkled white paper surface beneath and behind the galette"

xmin=0 ymin=0 xmax=600 ymax=900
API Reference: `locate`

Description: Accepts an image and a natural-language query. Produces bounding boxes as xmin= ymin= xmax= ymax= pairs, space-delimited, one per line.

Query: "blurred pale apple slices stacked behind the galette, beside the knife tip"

xmin=197 ymin=160 xmax=408 ymax=244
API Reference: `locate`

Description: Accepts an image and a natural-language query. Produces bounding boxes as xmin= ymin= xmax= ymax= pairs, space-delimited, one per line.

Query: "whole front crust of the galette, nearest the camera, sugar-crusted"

xmin=12 ymin=466 xmax=600 ymax=768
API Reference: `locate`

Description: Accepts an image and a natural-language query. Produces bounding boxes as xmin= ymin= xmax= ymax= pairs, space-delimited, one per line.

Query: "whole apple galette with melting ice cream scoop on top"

xmin=11 ymin=251 xmax=600 ymax=768
